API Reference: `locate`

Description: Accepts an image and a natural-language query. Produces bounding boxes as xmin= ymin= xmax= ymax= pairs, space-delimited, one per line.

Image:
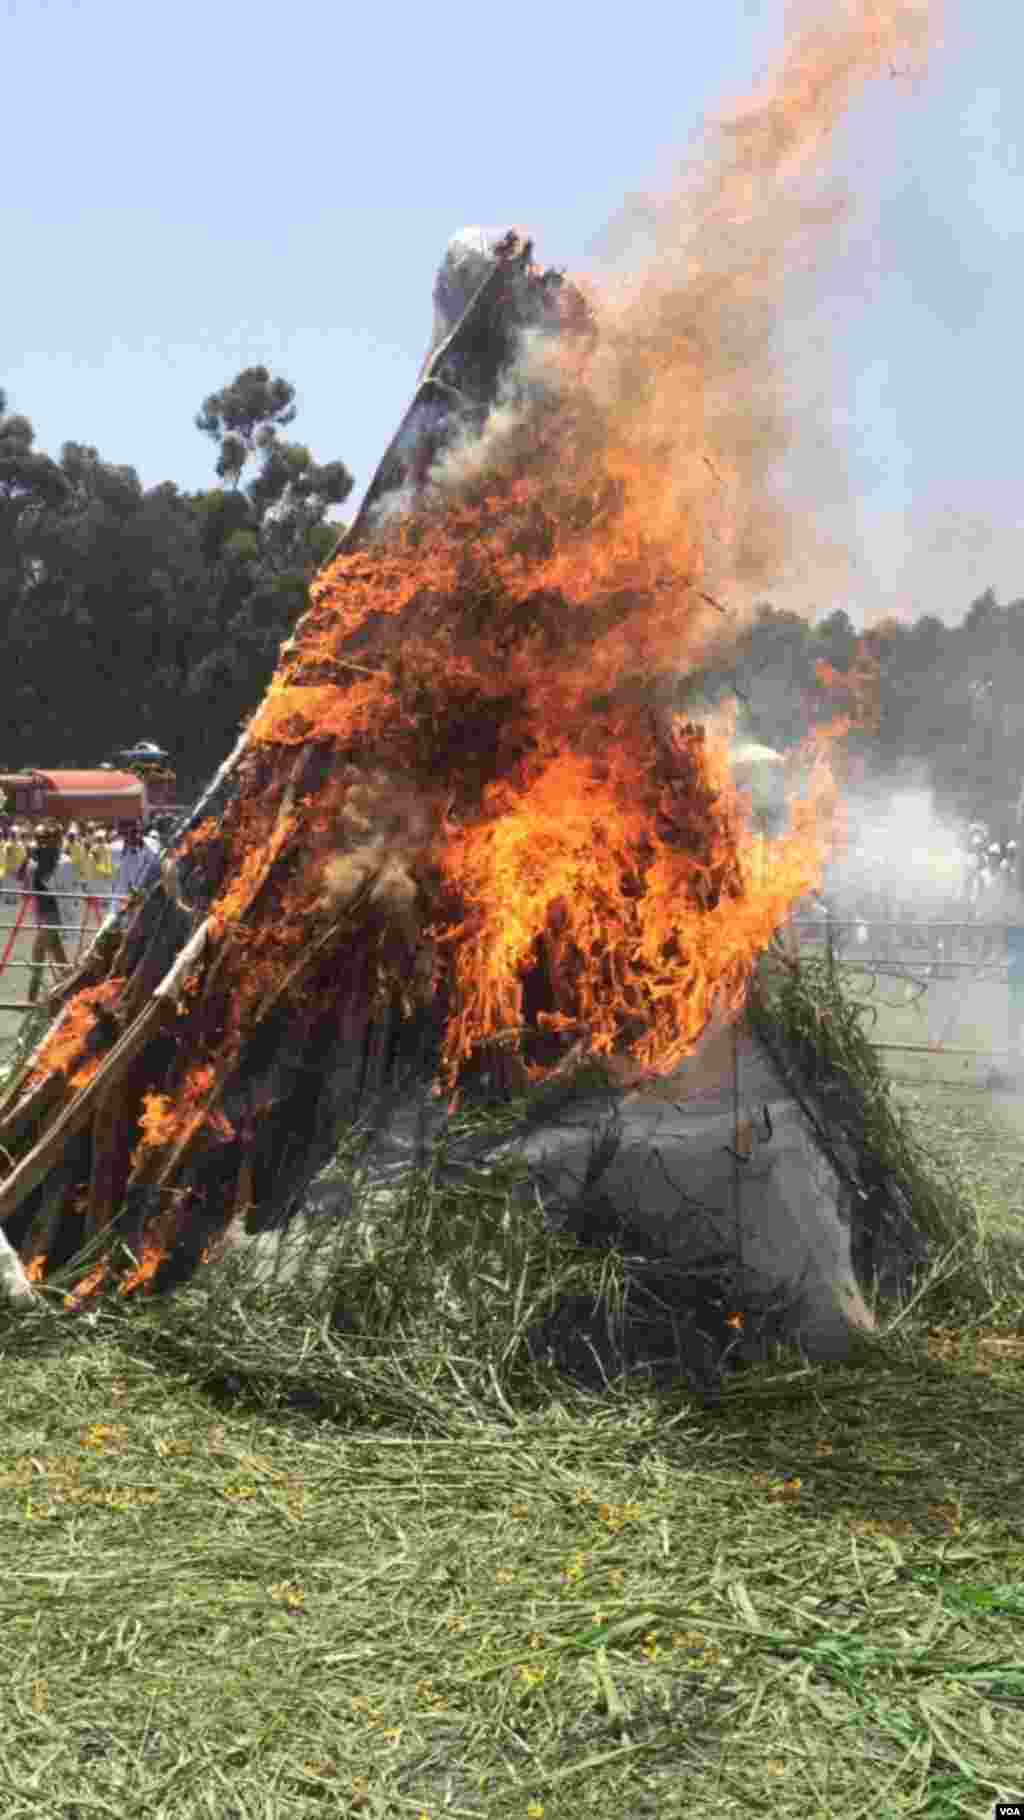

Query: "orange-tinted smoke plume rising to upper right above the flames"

xmin=431 ymin=0 xmax=935 ymax=666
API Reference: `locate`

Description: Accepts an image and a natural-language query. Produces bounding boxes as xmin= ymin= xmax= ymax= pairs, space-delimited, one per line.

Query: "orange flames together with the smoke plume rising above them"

xmin=36 ymin=0 xmax=931 ymax=1290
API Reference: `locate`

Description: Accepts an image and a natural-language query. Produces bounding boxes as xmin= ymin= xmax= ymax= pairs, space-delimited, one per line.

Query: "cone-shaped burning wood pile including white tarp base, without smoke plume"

xmin=0 ymin=231 xmax=938 ymax=1356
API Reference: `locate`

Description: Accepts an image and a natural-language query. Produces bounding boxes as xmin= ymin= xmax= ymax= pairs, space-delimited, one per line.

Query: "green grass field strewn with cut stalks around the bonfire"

xmin=0 ymin=960 xmax=1024 ymax=1820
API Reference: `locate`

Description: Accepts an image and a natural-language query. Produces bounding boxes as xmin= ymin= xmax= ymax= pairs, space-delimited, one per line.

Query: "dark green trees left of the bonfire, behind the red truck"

xmin=0 ymin=366 xmax=353 ymax=794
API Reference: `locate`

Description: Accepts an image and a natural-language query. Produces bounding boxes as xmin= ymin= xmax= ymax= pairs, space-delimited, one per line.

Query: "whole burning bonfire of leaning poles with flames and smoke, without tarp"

xmin=0 ymin=5 xmax=938 ymax=1307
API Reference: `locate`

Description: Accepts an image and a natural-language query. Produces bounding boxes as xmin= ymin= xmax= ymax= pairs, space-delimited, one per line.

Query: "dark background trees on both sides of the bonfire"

xmin=0 ymin=376 xmax=1024 ymax=826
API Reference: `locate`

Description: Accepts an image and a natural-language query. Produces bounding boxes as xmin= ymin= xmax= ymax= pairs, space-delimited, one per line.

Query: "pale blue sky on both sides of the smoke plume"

xmin=0 ymin=0 xmax=1024 ymax=617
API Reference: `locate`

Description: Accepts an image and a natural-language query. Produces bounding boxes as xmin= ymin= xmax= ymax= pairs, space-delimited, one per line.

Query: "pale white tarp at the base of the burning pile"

xmin=104 ymin=1023 xmax=875 ymax=1360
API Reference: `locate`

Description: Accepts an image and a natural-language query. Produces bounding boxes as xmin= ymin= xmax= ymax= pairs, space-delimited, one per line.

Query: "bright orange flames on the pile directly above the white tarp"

xmin=438 ymin=709 xmax=831 ymax=1077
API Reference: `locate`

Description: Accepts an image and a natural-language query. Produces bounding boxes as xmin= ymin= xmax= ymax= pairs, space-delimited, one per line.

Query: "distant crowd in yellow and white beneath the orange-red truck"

xmin=0 ymin=815 xmax=173 ymax=1005
